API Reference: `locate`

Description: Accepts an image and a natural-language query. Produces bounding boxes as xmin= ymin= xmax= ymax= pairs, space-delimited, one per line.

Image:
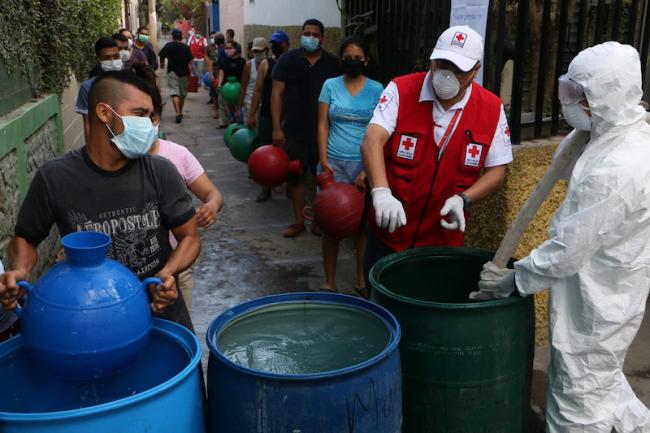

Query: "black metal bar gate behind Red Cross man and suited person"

xmin=343 ymin=0 xmax=650 ymax=143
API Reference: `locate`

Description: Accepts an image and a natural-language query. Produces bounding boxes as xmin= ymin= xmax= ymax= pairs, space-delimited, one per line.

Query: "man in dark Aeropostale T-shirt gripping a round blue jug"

xmin=0 ymin=71 xmax=200 ymax=329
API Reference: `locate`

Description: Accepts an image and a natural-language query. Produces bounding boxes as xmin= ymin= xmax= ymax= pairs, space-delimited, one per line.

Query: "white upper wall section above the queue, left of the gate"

xmin=244 ymin=0 xmax=341 ymax=27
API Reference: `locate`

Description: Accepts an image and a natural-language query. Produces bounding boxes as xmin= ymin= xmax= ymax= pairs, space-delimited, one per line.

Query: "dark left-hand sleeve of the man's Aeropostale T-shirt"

xmin=14 ymin=170 xmax=55 ymax=246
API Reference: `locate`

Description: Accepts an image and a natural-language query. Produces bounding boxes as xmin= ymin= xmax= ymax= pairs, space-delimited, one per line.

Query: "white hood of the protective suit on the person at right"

xmin=567 ymin=42 xmax=645 ymax=138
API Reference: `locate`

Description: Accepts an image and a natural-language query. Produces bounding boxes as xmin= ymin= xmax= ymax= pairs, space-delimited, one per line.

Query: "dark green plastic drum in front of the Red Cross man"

xmin=370 ymin=248 xmax=535 ymax=433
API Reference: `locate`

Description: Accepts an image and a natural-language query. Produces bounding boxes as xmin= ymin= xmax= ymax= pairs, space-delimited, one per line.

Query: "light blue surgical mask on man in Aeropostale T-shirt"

xmin=106 ymin=105 xmax=156 ymax=159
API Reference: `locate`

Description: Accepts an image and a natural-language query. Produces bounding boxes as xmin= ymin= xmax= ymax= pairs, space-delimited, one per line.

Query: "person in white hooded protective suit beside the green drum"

xmin=470 ymin=42 xmax=650 ymax=433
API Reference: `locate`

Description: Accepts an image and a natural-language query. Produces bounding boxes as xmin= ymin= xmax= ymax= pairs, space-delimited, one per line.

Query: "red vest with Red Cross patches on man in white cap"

xmin=369 ymin=72 xmax=501 ymax=251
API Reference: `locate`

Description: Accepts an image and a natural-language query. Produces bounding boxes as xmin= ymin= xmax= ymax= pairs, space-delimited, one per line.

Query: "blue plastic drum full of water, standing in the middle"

xmin=206 ymin=293 xmax=402 ymax=433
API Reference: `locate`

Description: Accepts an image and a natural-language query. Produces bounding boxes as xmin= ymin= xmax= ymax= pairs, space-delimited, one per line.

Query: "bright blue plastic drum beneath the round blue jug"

xmin=0 ymin=319 xmax=205 ymax=433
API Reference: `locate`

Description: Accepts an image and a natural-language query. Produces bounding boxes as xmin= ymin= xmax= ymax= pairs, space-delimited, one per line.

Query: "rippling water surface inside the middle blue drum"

xmin=213 ymin=303 xmax=390 ymax=375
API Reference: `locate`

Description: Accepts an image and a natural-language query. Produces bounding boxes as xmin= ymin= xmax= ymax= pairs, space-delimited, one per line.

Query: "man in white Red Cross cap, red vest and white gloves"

xmin=361 ymin=26 xmax=512 ymax=270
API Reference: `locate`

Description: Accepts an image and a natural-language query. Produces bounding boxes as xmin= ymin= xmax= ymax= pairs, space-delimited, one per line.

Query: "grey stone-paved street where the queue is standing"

xmin=158 ymin=67 xmax=650 ymax=426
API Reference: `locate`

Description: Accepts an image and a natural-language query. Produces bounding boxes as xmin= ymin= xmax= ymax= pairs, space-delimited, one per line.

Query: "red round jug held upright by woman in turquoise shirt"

xmin=312 ymin=170 xmax=363 ymax=239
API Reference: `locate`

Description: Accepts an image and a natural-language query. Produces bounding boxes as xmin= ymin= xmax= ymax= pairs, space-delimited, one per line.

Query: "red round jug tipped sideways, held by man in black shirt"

xmin=248 ymin=144 xmax=302 ymax=187
